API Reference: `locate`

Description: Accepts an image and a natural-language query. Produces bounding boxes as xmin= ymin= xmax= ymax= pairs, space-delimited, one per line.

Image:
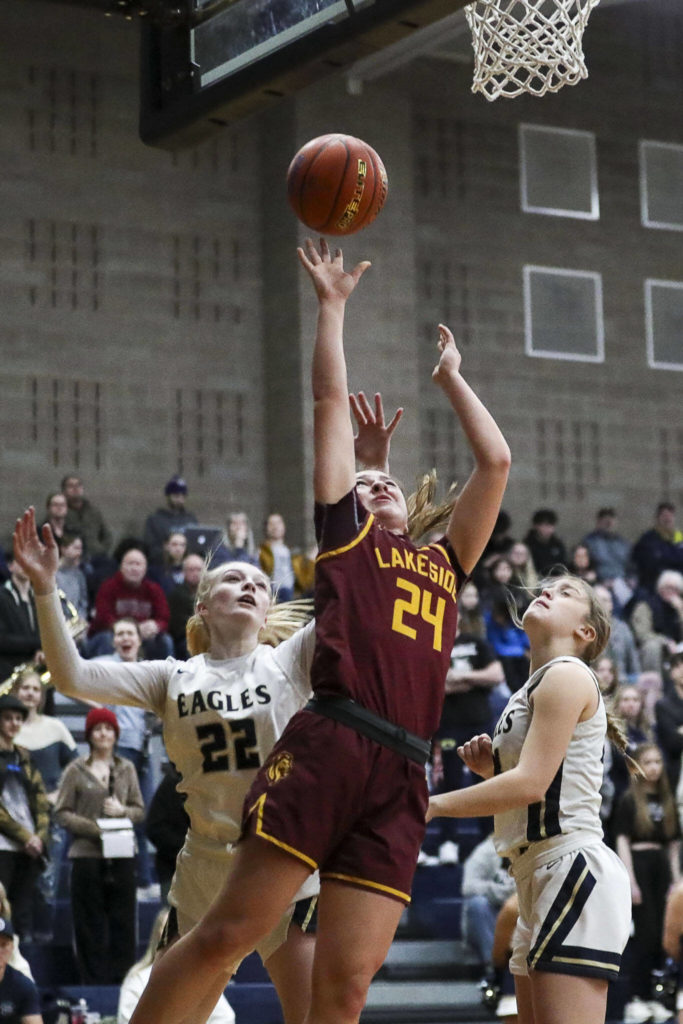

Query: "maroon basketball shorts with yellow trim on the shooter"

xmin=244 ymin=711 xmax=428 ymax=903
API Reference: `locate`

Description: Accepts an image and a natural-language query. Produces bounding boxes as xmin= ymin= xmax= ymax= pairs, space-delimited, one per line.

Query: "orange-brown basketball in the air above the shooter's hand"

xmin=287 ymin=135 xmax=389 ymax=234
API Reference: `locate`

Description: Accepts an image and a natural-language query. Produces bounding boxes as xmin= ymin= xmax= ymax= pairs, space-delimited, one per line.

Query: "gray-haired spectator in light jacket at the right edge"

xmin=631 ymin=569 xmax=683 ymax=673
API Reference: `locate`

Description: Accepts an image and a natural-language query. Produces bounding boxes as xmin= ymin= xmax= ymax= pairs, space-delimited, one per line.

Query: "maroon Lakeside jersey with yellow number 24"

xmin=311 ymin=488 xmax=466 ymax=739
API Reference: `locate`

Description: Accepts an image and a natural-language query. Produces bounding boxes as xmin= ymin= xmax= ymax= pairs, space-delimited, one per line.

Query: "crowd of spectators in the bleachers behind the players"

xmin=0 ymin=474 xmax=683 ymax=1019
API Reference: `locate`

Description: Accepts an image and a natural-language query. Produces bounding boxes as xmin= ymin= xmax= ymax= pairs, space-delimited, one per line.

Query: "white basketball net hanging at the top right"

xmin=465 ymin=0 xmax=599 ymax=99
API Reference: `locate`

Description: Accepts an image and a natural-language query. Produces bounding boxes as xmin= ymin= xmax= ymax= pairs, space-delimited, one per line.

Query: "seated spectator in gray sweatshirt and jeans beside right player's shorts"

xmin=462 ymin=836 xmax=515 ymax=967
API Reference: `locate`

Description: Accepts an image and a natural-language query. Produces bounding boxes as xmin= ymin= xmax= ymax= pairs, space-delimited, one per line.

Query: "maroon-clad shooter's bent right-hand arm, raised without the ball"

xmin=432 ymin=324 xmax=510 ymax=572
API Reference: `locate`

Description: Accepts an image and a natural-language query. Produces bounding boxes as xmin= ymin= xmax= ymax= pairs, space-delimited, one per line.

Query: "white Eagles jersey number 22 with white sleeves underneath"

xmin=66 ymin=622 xmax=315 ymax=846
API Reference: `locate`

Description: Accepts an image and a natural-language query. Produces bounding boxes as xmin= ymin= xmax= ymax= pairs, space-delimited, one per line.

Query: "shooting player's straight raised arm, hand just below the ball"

xmin=297 ymin=239 xmax=370 ymax=504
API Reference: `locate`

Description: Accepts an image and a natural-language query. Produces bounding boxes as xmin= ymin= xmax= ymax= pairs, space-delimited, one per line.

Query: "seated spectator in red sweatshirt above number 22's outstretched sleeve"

xmin=88 ymin=548 xmax=173 ymax=658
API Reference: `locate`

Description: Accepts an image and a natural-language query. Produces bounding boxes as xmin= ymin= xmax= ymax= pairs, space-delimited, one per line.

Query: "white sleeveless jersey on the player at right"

xmin=493 ymin=655 xmax=607 ymax=857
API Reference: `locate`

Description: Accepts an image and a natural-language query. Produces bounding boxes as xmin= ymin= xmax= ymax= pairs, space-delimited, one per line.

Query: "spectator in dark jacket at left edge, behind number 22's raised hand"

xmin=0 ymin=558 xmax=44 ymax=683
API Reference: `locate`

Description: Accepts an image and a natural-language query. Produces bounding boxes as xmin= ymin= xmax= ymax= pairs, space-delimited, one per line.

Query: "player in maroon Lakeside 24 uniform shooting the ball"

xmin=125 ymin=240 xmax=510 ymax=1024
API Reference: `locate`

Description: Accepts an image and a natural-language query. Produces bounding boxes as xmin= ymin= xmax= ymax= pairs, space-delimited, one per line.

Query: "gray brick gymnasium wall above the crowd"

xmin=0 ymin=0 xmax=683 ymax=557
